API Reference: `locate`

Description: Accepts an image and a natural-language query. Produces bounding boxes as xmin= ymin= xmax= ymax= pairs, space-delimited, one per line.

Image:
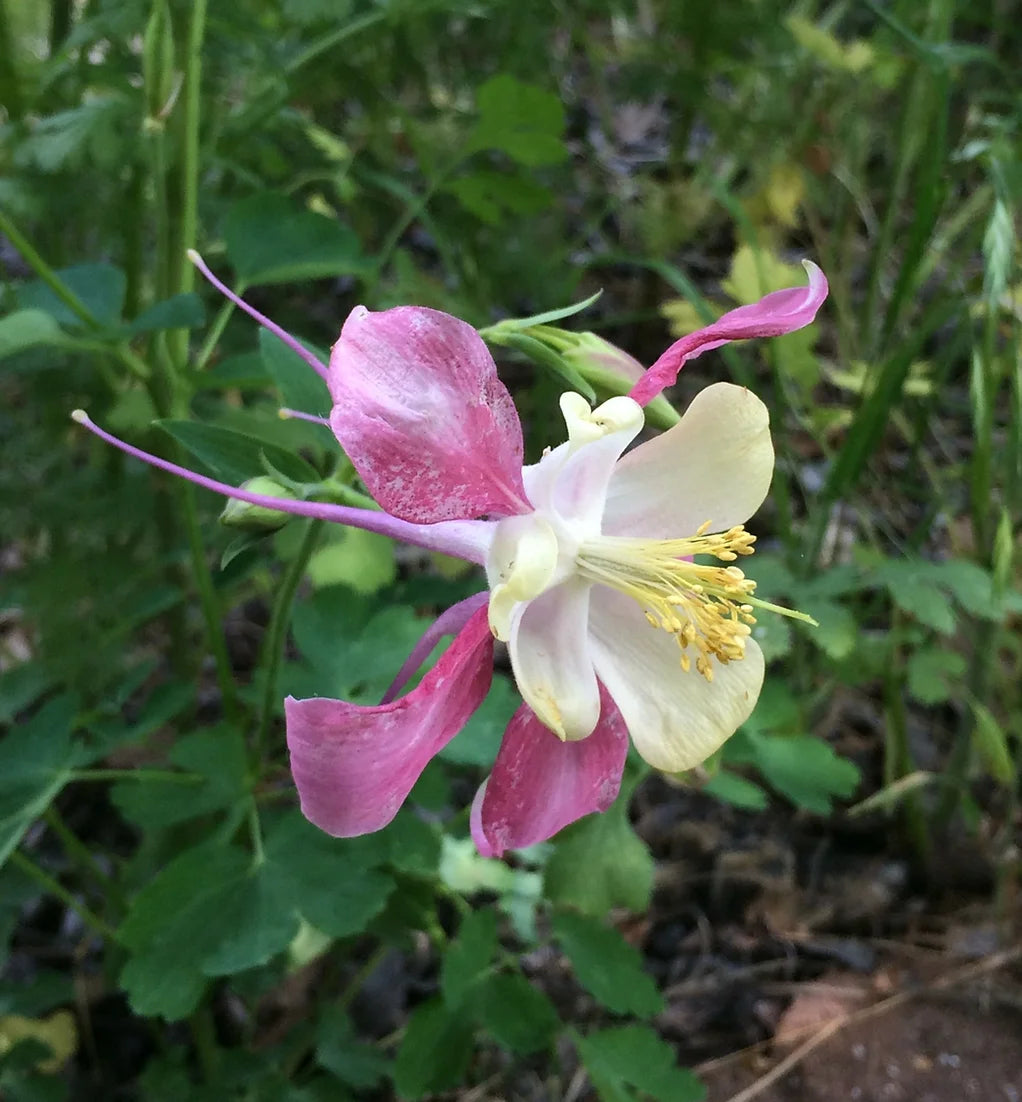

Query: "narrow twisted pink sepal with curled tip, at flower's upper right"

xmin=628 ymin=260 xmax=828 ymax=406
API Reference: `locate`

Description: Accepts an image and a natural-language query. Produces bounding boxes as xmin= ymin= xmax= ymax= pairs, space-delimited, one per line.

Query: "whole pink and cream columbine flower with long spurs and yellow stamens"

xmin=75 ymin=257 xmax=827 ymax=855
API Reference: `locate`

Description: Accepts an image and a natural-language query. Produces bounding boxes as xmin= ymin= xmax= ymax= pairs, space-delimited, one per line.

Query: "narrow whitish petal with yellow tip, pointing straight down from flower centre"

xmin=507 ymin=579 xmax=600 ymax=739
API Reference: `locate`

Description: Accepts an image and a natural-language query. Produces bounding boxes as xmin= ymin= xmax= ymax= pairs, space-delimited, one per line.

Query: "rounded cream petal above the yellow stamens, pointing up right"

xmin=603 ymin=382 xmax=774 ymax=539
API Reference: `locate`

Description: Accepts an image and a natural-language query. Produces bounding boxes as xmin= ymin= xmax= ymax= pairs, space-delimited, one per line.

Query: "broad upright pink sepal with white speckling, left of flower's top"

xmin=330 ymin=306 xmax=528 ymax=523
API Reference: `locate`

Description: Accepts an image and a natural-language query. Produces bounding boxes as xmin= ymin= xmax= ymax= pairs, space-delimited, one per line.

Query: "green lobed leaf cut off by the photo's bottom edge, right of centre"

xmin=577 ymin=1025 xmax=707 ymax=1102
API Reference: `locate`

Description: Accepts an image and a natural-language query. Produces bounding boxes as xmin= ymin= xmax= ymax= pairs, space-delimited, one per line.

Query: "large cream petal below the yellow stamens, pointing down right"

xmin=590 ymin=586 xmax=764 ymax=773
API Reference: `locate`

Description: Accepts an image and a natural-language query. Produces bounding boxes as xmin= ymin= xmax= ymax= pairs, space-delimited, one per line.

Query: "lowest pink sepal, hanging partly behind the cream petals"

xmin=470 ymin=685 xmax=628 ymax=857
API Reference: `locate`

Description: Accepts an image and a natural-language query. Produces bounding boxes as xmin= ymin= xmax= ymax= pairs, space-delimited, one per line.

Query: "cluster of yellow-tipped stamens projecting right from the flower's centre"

xmin=575 ymin=520 xmax=762 ymax=681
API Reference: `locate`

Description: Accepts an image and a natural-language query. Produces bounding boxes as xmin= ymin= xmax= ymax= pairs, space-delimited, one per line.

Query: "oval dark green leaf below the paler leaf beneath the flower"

xmin=552 ymin=914 xmax=664 ymax=1017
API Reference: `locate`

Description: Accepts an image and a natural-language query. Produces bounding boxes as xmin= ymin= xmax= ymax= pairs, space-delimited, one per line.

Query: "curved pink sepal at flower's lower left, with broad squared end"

xmin=284 ymin=608 xmax=493 ymax=838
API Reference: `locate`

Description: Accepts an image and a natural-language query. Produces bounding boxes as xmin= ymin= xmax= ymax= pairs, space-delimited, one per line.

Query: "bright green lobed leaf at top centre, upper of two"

xmin=469 ymin=73 xmax=568 ymax=168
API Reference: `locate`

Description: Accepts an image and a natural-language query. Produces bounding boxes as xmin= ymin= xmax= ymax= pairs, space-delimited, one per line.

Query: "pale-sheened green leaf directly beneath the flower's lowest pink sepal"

xmin=544 ymin=796 xmax=653 ymax=916
